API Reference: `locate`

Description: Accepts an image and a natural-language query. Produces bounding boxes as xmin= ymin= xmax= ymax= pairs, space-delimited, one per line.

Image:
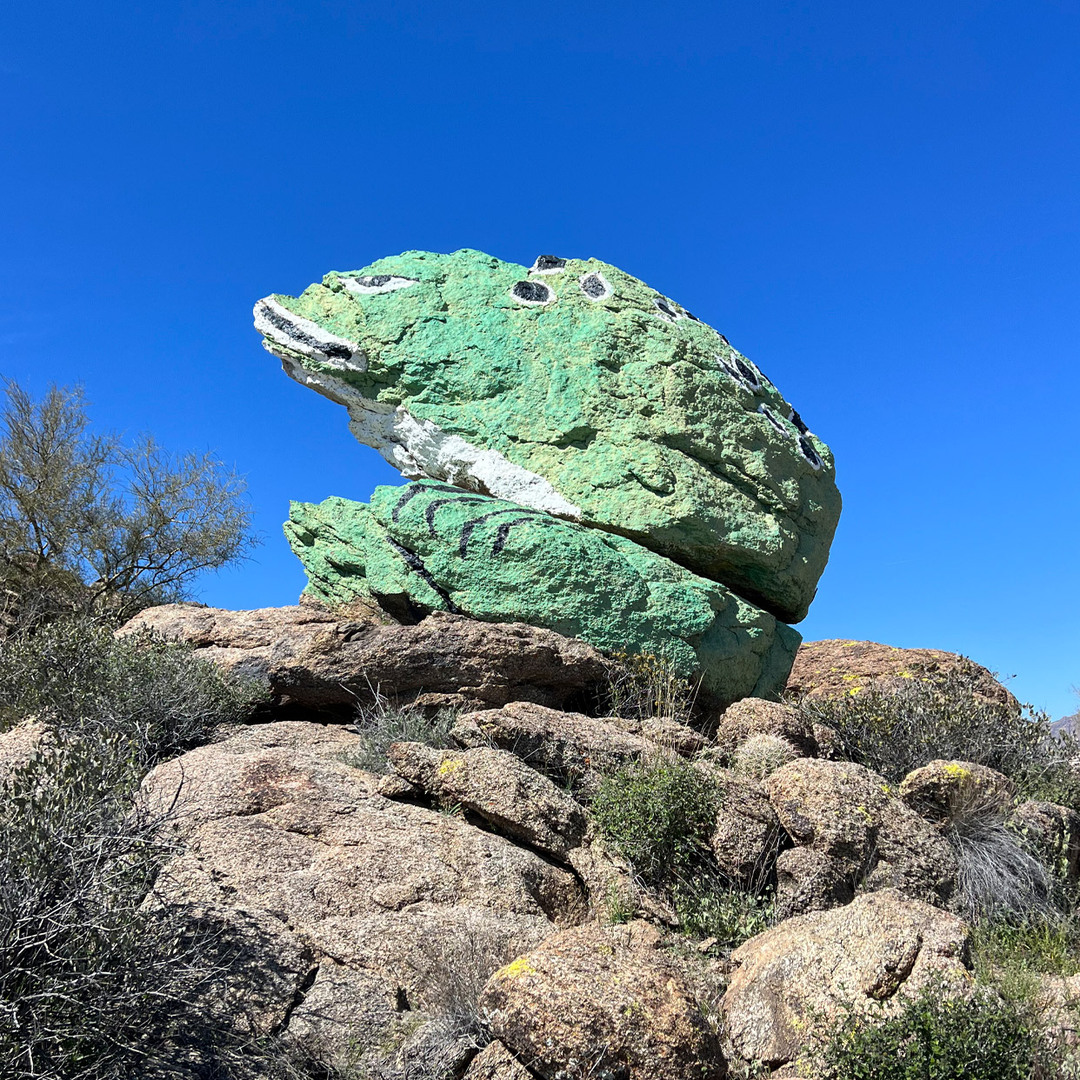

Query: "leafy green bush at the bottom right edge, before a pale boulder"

xmin=824 ymin=985 xmax=1037 ymax=1080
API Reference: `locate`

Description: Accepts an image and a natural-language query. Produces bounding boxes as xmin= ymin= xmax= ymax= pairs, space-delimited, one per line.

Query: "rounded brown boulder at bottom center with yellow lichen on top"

xmin=480 ymin=922 xmax=726 ymax=1080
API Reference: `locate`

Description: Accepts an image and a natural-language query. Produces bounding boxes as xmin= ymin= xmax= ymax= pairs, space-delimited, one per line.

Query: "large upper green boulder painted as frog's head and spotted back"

xmin=255 ymin=251 xmax=840 ymax=622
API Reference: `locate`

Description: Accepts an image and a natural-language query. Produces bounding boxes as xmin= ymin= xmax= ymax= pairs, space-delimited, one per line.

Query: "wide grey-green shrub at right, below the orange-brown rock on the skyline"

xmin=800 ymin=672 xmax=1080 ymax=806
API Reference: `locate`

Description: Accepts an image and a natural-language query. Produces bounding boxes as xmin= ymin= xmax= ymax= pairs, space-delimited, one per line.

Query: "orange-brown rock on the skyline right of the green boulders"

xmin=787 ymin=639 xmax=1020 ymax=713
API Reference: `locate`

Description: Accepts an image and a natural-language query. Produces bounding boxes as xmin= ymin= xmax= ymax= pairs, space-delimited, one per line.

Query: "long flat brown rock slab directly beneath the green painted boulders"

xmin=120 ymin=603 xmax=610 ymax=707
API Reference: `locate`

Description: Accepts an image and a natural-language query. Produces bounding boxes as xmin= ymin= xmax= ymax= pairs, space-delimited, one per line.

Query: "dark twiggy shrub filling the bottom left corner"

xmin=0 ymin=734 xmax=315 ymax=1080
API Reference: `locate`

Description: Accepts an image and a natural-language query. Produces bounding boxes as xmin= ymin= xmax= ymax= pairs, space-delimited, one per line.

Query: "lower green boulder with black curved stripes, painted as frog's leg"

xmin=285 ymin=481 xmax=800 ymax=704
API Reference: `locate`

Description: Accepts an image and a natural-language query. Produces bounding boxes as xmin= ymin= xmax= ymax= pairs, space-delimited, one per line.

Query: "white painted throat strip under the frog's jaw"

xmin=274 ymin=341 xmax=581 ymax=522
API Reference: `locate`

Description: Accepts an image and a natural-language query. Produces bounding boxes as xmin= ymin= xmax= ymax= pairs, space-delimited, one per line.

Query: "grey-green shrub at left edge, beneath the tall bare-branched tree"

xmin=0 ymin=619 xmax=262 ymax=772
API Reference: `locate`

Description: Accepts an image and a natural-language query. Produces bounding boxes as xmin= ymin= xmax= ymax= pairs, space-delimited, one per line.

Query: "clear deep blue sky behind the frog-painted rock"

xmin=0 ymin=6 xmax=1080 ymax=716
